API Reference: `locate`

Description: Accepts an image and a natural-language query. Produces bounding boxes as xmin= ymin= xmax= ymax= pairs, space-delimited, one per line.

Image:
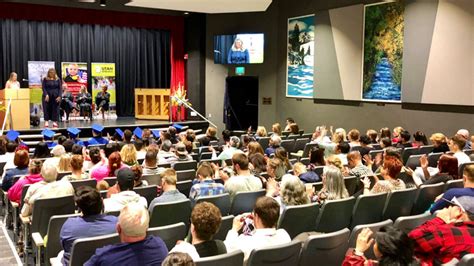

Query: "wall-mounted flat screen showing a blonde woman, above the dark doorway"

xmin=214 ymin=33 xmax=264 ymax=65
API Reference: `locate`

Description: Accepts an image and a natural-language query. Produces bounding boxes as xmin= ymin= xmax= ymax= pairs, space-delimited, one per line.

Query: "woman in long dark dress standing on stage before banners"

xmin=43 ymin=68 xmax=61 ymax=128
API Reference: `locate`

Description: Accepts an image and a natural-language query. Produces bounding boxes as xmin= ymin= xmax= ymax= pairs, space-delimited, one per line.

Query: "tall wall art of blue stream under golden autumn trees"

xmin=362 ymin=1 xmax=404 ymax=102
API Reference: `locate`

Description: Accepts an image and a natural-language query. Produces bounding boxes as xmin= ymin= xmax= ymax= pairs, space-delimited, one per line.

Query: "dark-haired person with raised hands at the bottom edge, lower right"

xmin=342 ymin=225 xmax=417 ymax=266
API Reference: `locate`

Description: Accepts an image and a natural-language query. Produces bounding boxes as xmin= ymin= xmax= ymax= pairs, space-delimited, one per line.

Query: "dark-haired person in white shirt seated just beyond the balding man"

xmin=104 ymin=168 xmax=148 ymax=212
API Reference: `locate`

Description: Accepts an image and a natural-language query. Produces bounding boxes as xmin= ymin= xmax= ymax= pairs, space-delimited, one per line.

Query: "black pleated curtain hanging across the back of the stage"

xmin=0 ymin=20 xmax=171 ymax=116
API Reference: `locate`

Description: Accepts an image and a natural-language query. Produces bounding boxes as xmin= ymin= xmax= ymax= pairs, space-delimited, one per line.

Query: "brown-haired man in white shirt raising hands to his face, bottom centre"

xmin=224 ymin=197 xmax=291 ymax=261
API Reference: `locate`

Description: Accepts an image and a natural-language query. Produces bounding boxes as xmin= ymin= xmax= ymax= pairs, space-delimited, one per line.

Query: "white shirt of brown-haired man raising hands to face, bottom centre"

xmin=224 ymin=228 xmax=291 ymax=261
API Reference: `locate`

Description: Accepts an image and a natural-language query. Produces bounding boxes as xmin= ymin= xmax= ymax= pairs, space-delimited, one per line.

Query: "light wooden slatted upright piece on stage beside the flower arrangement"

xmin=135 ymin=88 xmax=170 ymax=120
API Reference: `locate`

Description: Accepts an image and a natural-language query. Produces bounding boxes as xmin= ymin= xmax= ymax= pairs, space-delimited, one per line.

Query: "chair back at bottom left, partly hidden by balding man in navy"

xmin=69 ymin=233 xmax=120 ymax=266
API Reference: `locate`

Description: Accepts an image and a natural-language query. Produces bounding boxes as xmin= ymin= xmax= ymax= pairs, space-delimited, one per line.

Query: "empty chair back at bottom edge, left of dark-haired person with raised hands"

xmin=299 ymin=228 xmax=351 ymax=266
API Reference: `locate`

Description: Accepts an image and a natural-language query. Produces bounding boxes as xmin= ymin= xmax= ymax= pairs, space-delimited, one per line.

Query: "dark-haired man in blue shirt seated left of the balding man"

xmin=59 ymin=187 xmax=117 ymax=265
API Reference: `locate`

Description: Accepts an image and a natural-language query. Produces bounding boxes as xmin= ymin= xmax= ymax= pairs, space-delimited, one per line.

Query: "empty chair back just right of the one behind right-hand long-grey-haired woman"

xmin=351 ymin=193 xmax=387 ymax=228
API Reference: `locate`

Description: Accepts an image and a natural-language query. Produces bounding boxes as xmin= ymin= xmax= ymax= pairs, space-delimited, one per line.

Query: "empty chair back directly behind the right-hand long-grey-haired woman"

xmin=316 ymin=197 xmax=356 ymax=233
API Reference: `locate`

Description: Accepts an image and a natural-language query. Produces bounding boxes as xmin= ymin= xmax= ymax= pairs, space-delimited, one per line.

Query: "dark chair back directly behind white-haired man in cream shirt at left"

xmin=31 ymin=195 xmax=76 ymax=236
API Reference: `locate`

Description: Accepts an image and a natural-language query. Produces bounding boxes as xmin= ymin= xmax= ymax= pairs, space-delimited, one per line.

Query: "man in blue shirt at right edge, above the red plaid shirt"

xmin=430 ymin=165 xmax=474 ymax=213
